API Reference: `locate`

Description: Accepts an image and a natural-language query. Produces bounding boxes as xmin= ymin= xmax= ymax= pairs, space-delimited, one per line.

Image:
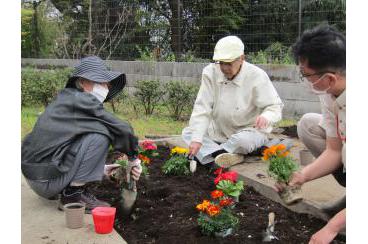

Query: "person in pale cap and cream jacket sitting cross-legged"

xmin=182 ymin=36 xmax=283 ymax=167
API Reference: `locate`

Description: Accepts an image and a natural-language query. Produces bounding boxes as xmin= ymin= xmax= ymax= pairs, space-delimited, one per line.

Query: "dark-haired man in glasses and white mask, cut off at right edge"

xmin=276 ymin=26 xmax=346 ymax=244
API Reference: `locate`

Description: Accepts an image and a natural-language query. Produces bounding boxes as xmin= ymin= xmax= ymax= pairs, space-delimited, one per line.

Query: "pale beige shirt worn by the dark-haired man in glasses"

xmin=320 ymin=91 xmax=346 ymax=167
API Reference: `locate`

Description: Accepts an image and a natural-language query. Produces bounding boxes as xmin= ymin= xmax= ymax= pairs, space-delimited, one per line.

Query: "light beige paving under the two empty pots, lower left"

xmin=21 ymin=176 xmax=127 ymax=244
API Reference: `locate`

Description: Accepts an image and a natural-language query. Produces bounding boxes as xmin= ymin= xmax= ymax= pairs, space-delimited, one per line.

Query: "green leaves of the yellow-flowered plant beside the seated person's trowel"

xmin=162 ymin=154 xmax=190 ymax=175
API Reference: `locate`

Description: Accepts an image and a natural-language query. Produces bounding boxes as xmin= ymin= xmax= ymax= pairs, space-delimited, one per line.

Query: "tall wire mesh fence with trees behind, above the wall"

xmin=22 ymin=0 xmax=346 ymax=64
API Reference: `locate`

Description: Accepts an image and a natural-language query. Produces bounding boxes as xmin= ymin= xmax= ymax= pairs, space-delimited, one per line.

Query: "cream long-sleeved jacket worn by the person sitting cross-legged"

xmin=189 ymin=61 xmax=284 ymax=142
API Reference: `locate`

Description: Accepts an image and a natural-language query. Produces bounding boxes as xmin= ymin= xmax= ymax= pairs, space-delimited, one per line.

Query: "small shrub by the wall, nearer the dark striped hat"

xmin=134 ymin=80 xmax=165 ymax=115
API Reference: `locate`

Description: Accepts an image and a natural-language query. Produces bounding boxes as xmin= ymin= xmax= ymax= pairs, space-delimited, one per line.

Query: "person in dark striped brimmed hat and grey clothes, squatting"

xmin=21 ymin=56 xmax=142 ymax=213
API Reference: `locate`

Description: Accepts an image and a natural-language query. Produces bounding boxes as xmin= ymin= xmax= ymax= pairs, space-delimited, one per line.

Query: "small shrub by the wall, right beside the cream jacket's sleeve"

xmin=165 ymin=81 xmax=199 ymax=120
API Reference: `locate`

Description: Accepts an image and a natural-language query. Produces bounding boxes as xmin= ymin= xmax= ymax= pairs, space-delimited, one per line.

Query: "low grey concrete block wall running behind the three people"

xmin=22 ymin=58 xmax=320 ymax=118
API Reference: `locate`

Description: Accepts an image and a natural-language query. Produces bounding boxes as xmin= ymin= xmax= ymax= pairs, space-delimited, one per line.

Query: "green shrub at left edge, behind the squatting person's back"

xmin=21 ymin=67 xmax=71 ymax=106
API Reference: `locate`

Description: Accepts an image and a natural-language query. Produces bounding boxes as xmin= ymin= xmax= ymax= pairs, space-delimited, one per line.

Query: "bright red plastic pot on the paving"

xmin=92 ymin=207 xmax=116 ymax=234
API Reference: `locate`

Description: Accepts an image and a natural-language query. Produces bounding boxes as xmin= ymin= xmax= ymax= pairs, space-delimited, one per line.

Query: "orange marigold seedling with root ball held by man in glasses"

xmin=263 ymin=144 xmax=302 ymax=205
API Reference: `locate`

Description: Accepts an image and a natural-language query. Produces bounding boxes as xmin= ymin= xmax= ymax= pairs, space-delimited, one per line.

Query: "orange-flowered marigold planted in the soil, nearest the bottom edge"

xmin=196 ymin=190 xmax=239 ymax=237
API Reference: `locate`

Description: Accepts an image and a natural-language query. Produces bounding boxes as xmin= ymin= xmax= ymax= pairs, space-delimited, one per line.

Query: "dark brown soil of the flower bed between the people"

xmin=89 ymin=147 xmax=345 ymax=244
